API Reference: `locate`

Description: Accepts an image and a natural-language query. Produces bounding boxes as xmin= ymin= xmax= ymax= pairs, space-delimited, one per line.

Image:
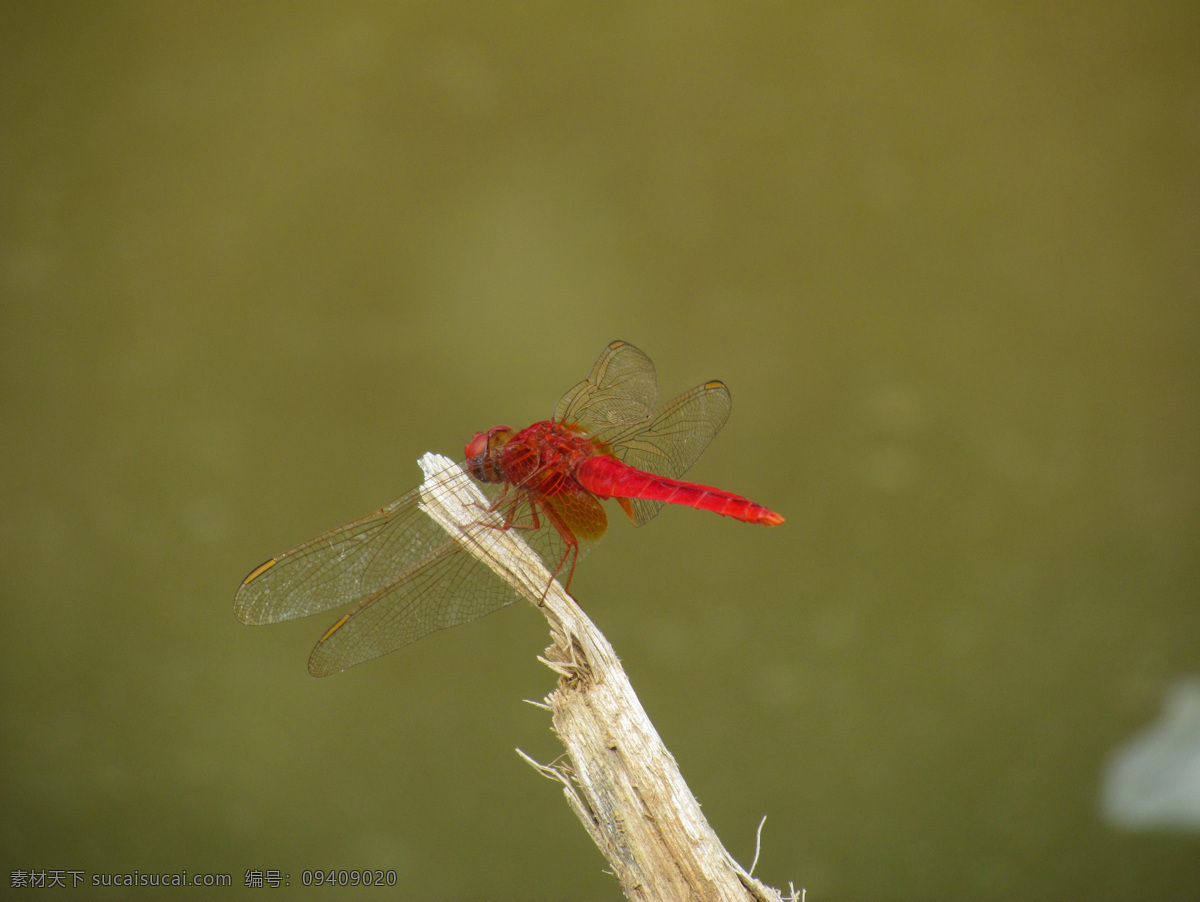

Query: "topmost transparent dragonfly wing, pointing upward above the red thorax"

xmin=554 ymin=342 xmax=659 ymax=433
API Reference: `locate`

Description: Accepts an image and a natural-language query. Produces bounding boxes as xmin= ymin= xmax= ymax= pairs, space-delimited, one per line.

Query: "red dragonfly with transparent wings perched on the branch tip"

xmin=234 ymin=342 xmax=784 ymax=677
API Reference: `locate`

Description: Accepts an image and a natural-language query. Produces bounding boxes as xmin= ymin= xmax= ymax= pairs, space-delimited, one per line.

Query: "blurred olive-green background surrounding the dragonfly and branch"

xmin=0 ymin=2 xmax=1200 ymax=900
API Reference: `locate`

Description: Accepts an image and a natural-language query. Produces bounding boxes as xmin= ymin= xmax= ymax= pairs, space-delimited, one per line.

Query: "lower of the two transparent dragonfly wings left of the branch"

xmin=308 ymin=527 xmax=521 ymax=677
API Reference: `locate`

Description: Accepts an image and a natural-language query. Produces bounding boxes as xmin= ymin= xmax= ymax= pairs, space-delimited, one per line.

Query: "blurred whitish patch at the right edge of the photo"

xmin=1100 ymin=677 xmax=1200 ymax=830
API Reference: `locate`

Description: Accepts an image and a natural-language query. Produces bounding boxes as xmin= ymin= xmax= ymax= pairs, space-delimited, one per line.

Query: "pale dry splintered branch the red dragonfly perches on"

xmin=421 ymin=455 xmax=780 ymax=902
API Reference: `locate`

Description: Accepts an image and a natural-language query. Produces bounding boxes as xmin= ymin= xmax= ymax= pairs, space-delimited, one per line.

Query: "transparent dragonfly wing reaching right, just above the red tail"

xmin=599 ymin=380 xmax=732 ymax=527
